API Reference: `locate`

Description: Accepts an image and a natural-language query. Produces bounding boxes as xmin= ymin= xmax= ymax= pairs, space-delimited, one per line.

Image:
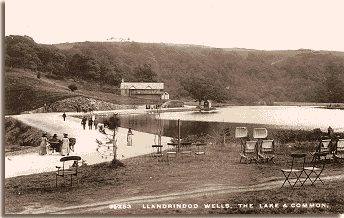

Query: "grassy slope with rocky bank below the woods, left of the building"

xmin=4 ymin=69 xmax=163 ymax=115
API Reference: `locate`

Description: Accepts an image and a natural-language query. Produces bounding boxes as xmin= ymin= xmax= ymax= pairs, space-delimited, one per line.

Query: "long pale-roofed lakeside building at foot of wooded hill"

xmin=121 ymin=79 xmax=168 ymax=99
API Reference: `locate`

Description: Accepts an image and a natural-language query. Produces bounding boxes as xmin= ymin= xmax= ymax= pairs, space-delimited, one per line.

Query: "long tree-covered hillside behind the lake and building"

xmin=5 ymin=35 xmax=344 ymax=104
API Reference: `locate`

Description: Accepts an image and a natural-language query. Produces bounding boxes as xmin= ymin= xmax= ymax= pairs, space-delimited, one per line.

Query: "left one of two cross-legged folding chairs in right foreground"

xmin=281 ymin=154 xmax=306 ymax=189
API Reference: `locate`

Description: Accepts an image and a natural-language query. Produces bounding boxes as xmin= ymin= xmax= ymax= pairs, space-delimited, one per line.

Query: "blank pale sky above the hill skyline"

xmin=5 ymin=0 xmax=344 ymax=51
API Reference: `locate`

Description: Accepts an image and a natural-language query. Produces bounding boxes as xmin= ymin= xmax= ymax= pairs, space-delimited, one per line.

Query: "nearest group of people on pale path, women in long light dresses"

xmin=39 ymin=133 xmax=71 ymax=156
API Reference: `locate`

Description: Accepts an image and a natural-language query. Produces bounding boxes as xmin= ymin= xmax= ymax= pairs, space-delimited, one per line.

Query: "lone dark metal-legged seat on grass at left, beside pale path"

xmin=56 ymin=156 xmax=81 ymax=187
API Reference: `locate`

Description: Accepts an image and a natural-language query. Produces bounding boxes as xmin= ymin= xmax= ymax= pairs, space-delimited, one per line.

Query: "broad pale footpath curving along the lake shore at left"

xmin=5 ymin=107 xmax=199 ymax=178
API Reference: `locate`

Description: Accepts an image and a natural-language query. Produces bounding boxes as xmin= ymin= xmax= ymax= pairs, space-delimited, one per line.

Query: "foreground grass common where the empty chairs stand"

xmin=4 ymin=143 xmax=344 ymax=215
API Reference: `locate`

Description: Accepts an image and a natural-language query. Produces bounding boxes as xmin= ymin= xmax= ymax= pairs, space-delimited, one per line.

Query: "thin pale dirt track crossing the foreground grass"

xmin=16 ymin=174 xmax=344 ymax=214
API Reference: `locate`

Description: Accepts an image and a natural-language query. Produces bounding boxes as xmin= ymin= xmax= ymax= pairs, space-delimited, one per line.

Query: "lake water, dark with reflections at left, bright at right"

xmin=116 ymin=106 xmax=344 ymax=138
